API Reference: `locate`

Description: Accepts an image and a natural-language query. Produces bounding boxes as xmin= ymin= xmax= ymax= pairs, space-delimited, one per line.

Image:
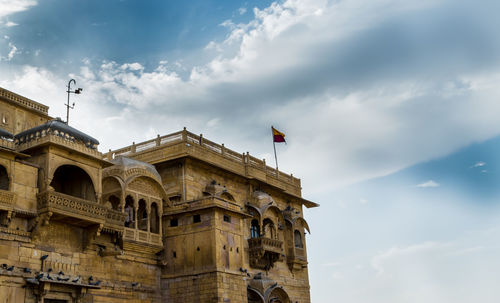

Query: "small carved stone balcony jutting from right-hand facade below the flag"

xmin=248 ymin=237 xmax=283 ymax=270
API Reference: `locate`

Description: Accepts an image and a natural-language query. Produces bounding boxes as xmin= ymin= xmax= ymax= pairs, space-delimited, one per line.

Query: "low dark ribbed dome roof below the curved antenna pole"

xmin=14 ymin=118 xmax=99 ymax=149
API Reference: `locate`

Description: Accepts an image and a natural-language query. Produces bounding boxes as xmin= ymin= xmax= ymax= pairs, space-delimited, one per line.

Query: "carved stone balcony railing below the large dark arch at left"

xmin=38 ymin=191 xmax=108 ymax=227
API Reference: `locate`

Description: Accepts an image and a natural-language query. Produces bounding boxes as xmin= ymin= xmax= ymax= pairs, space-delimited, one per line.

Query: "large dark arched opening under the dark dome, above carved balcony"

xmin=50 ymin=165 xmax=96 ymax=202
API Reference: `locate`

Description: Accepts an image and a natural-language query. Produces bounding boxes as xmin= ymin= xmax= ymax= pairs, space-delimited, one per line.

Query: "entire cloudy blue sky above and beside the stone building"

xmin=0 ymin=0 xmax=500 ymax=303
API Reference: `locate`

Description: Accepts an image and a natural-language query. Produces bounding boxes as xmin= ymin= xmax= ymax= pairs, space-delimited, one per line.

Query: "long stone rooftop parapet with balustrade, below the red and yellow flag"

xmin=104 ymin=129 xmax=301 ymax=197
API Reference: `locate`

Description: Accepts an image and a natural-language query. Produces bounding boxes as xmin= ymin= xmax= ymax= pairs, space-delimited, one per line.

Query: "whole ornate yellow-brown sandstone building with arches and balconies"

xmin=0 ymin=88 xmax=318 ymax=303
